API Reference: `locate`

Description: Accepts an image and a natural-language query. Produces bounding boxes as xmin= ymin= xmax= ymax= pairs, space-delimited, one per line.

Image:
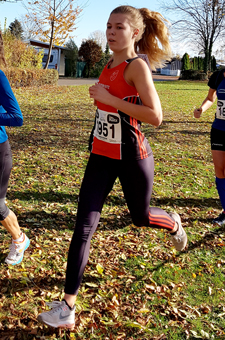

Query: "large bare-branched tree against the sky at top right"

xmin=162 ymin=0 xmax=225 ymax=73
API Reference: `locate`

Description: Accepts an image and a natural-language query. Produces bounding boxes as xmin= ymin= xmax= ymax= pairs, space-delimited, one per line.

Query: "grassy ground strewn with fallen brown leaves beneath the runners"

xmin=0 ymin=81 xmax=225 ymax=340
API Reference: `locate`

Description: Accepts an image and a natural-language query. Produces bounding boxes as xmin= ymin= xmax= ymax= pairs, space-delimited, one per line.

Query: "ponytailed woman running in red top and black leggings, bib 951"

xmin=38 ymin=6 xmax=187 ymax=327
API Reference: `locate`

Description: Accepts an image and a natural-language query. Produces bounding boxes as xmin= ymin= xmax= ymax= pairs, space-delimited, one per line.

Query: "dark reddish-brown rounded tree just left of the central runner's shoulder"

xmin=79 ymin=39 xmax=102 ymax=77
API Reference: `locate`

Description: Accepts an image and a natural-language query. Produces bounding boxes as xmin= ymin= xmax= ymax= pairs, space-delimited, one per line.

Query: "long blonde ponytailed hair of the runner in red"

xmin=111 ymin=6 xmax=172 ymax=70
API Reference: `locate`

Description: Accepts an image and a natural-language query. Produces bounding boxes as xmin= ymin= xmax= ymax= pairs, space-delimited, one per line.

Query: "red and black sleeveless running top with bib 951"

xmin=90 ymin=58 xmax=152 ymax=159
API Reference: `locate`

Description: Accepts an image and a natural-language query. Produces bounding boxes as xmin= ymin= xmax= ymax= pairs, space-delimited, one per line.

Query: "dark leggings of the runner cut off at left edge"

xmin=0 ymin=140 xmax=12 ymax=221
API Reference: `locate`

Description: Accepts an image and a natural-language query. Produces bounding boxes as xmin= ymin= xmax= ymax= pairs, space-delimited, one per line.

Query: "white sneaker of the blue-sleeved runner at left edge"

xmin=5 ymin=233 xmax=30 ymax=266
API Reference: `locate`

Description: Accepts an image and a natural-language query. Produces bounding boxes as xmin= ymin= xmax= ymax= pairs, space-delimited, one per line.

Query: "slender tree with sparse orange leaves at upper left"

xmin=26 ymin=0 xmax=82 ymax=68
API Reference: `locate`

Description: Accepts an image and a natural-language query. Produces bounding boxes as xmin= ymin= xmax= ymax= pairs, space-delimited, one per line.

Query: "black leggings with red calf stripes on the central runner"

xmin=65 ymin=154 xmax=175 ymax=295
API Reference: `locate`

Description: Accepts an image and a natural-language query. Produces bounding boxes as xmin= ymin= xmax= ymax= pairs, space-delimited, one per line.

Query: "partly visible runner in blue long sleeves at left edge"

xmin=0 ymin=32 xmax=30 ymax=265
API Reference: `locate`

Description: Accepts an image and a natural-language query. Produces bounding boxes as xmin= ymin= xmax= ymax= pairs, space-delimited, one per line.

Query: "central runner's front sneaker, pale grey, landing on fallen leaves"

xmin=37 ymin=301 xmax=75 ymax=328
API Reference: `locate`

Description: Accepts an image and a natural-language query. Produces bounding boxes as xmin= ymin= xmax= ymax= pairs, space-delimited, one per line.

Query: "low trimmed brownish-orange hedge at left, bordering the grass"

xmin=3 ymin=67 xmax=59 ymax=87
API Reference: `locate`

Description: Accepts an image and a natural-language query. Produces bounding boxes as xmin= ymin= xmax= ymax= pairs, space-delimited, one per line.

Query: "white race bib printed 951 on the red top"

xmin=94 ymin=109 xmax=121 ymax=144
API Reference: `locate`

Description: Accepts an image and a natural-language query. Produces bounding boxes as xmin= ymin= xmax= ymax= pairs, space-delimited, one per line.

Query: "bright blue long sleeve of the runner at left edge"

xmin=0 ymin=70 xmax=23 ymax=126
